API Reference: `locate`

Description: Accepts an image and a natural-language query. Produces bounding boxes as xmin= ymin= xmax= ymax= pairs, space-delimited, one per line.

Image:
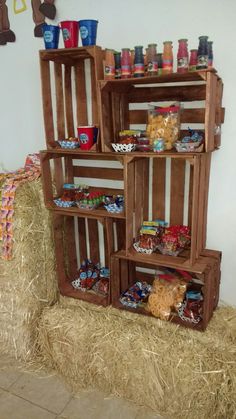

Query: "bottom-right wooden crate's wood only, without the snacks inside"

xmin=111 ymin=251 xmax=220 ymax=330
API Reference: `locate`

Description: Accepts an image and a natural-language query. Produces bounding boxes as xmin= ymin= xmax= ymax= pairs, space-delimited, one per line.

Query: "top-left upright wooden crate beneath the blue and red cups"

xmin=39 ymin=46 xmax=104 ymax=151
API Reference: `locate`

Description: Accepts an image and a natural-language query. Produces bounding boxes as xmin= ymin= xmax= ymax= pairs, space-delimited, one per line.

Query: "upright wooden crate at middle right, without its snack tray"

xmin=124 ymin=153 xmax=211 ymax=266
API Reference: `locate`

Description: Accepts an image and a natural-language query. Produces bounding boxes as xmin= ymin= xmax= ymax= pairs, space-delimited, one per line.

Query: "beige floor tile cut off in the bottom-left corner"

xmin=0 ymin=391 xmax=56 ymax=419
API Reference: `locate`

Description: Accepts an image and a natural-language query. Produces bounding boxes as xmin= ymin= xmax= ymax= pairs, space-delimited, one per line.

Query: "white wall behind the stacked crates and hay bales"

xmin=0 ymin=0 xmax=236 ymax=305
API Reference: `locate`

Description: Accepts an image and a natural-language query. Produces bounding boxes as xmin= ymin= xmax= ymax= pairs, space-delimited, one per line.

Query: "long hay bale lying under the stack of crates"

xmin=39 ymin=297 xmax=236 ymax=419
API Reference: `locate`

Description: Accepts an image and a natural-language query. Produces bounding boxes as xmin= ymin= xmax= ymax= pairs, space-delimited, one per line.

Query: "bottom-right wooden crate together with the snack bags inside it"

xmin=111 ymin=251 xmax=220 ymax=330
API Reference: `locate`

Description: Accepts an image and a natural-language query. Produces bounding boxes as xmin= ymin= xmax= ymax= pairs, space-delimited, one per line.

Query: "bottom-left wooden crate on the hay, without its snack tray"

xmin=53 ymin=212 xmax=115 ymax=306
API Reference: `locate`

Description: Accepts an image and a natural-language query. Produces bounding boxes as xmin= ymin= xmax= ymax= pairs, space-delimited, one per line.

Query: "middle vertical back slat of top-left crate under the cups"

xmin=64 ymin=66 xmax=74 ymax=137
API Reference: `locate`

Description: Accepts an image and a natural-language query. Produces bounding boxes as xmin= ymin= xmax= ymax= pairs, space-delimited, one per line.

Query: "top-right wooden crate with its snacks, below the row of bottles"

xmin=99 ymin=70 xmax=224 ymax=154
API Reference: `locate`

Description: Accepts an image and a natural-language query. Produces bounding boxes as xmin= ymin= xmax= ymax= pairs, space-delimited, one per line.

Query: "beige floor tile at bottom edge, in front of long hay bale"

xmin=58 ymin=391 xmax=137 ymax=419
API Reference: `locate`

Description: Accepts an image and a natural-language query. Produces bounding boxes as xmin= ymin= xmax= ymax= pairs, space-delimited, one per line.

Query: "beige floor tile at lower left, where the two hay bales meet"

xmin=11 ymin=373 xmax=72 ymax=414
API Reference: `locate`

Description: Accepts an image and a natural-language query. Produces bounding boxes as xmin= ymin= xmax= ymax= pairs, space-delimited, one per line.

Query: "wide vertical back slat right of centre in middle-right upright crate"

xmin=170 ymin=159 xmax=186 ymax=225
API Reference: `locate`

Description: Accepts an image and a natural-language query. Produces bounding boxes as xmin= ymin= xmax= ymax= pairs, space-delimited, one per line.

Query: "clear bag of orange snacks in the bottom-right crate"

xmin=146 ymin=275 xmax=187 ymax=320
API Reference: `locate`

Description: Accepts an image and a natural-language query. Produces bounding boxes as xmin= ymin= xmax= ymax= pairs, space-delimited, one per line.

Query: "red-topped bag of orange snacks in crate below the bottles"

xmin=146 ymin=103 xmax=180 ymax=151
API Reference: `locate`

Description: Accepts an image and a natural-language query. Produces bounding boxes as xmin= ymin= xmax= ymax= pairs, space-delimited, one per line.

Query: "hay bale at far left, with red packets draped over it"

xmin=0 ymin=179 xmax=58 ymax=360
